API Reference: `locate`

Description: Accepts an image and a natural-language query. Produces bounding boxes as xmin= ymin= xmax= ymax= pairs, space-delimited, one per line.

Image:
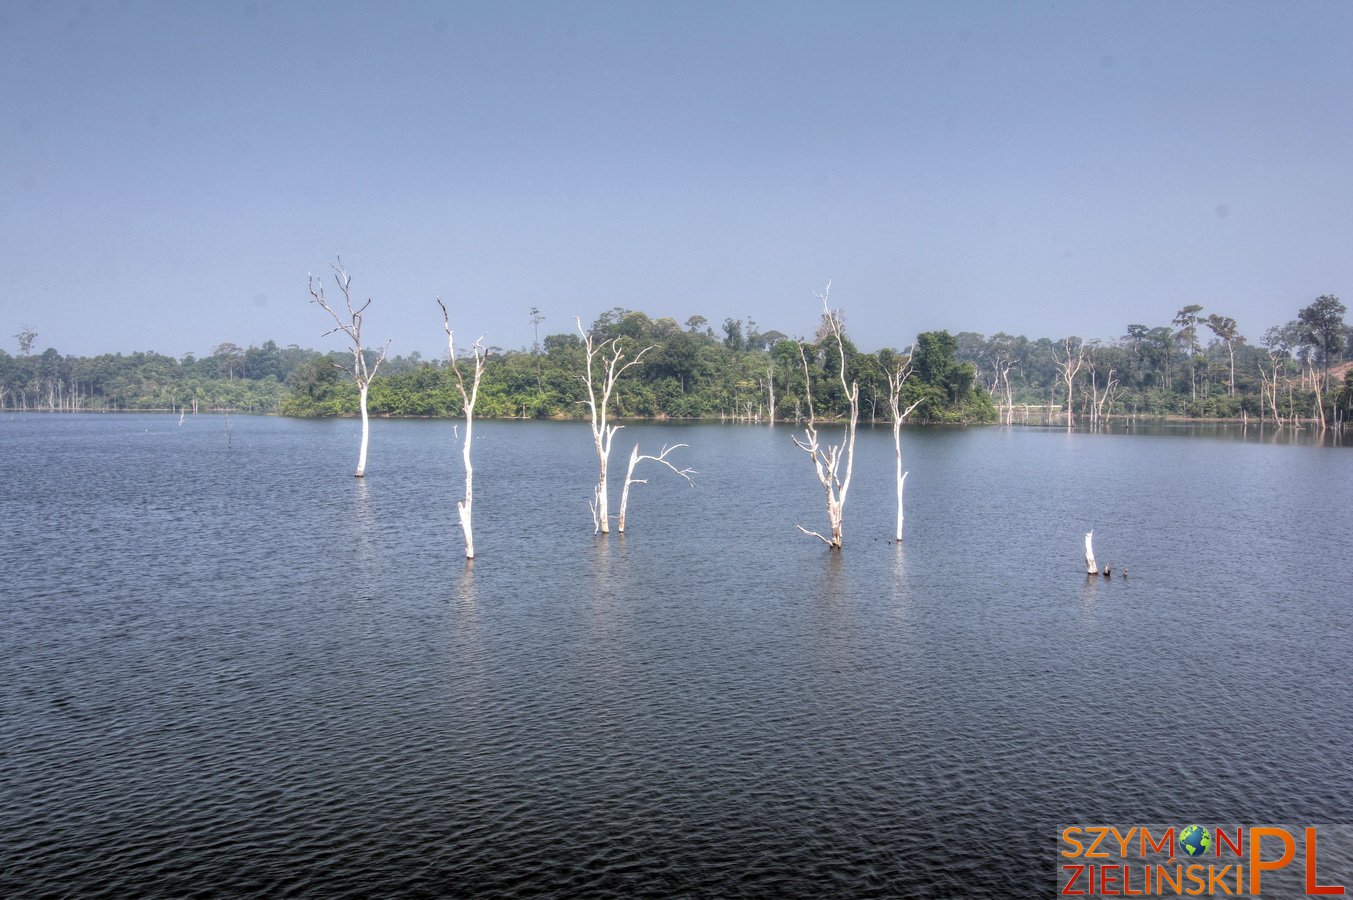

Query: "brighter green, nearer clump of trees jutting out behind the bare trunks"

xmin=281 ymin=307 xmax=996 ymax=422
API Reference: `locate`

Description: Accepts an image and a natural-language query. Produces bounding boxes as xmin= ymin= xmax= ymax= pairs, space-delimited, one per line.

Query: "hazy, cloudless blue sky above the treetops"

xmin=0 ymin=0 xmax=1353 ymax=357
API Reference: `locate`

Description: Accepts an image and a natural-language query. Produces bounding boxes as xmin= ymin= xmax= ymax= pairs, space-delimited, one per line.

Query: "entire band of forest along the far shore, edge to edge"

xmin=0 ymin=295 xmax=1353 ymax=426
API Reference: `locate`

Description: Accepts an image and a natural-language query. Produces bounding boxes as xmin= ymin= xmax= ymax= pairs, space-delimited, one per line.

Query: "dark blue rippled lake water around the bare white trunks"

xmin=0 ymin=414 xmax=1353 ymax=897
